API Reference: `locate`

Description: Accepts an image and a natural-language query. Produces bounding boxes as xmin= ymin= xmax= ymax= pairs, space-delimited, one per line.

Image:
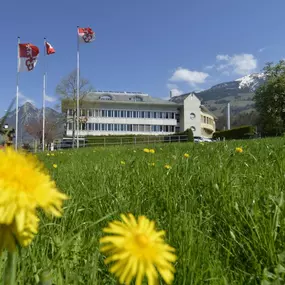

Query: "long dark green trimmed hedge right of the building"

xmin=213 ymin=126 xmax=256 ymax=140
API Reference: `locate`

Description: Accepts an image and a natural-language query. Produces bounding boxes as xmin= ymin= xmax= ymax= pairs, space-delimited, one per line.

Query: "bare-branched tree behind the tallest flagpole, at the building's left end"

xmin=56 ymin=70 xmax=92 ymax=147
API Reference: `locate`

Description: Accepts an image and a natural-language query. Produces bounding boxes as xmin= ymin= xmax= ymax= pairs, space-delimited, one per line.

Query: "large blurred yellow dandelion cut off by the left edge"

xmin=0 ymin=148 xmax=67 ymax=251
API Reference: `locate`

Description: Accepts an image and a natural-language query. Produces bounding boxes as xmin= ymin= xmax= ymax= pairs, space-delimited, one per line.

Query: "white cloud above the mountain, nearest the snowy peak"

xmin=216 ymin=53 xmax=257 ymax=75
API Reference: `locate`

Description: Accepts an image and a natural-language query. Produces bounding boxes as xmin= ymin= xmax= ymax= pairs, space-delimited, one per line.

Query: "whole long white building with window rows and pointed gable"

xmin=62 ymin=91 xmax=215 ymax=137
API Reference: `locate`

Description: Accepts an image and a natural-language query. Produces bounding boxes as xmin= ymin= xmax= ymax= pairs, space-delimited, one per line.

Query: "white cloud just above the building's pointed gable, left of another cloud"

xmin=169 ymin=67 xmax=209 ymax=86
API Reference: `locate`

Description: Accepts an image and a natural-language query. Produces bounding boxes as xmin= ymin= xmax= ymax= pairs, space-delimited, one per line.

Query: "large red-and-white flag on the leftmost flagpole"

xmin=18 ymin=43 xmax=40 ymax=72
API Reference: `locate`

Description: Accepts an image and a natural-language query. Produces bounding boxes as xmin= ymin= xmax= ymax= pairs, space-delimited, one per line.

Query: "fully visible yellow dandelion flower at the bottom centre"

xmin=100 ymin=214 xmax=176 ymax=285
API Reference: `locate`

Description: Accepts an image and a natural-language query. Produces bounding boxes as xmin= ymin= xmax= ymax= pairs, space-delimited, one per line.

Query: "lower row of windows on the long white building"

xmin=67 ymin=123 xmax=178 ymax=133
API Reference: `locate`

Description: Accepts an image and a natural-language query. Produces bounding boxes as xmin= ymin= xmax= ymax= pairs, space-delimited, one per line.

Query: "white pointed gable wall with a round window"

xmin=180 ymin=94 xmax=201 ymax=136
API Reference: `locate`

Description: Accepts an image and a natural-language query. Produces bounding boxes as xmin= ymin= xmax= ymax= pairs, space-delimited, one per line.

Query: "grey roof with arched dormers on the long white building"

xmin=81 ymin=91 xmax=177 ymax=106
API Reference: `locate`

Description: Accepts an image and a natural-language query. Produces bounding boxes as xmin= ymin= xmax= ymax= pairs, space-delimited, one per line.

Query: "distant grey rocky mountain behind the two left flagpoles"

xmin=2 ymin=102 xmax=64 ymax=142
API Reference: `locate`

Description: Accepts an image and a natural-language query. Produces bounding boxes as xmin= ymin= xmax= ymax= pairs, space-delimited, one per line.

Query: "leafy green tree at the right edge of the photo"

xmin=254 ymin=60 xmax=285 ymax=135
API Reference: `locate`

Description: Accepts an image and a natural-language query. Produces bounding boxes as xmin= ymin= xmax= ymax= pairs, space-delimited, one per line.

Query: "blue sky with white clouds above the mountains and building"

xmin=0 ymin=0 xmax=285 ymax=115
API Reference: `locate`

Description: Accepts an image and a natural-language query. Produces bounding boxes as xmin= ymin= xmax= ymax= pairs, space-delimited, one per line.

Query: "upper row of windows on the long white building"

xmin=67 ymin=109 xmax=175 ymax=119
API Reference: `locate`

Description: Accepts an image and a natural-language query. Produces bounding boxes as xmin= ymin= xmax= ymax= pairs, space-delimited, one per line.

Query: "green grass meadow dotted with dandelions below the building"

xmin=0 ymin=138 xmax=285 ymax=285
